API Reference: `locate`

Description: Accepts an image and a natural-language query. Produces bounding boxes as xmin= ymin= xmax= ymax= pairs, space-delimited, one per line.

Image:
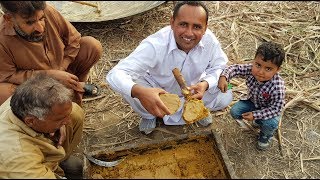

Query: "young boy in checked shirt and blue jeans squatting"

xmin=218 ymin=42 xmax=285 ymax=150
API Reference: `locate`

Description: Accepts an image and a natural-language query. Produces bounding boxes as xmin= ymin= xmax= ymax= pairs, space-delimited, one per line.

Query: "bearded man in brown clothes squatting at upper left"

xmin=0 ymin=1 xmax=102 ymax=105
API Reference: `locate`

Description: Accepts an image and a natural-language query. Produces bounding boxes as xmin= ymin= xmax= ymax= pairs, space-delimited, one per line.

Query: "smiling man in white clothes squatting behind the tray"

xmin=106 ymin=1 xmax=232 ymax=134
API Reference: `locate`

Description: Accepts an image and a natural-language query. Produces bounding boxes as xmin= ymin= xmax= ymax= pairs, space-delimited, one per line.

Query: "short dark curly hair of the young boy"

xmin=255 ymin=42 xmax=285 ymax=67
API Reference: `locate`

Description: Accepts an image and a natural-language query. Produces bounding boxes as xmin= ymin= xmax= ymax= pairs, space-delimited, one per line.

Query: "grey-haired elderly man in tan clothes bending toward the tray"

xmin=0 ymin=74 xmax=84 ymax=179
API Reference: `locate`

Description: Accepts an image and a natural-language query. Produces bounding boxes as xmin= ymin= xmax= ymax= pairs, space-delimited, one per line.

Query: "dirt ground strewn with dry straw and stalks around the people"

xmin=73 ymin=1 xmax=320 ymax=179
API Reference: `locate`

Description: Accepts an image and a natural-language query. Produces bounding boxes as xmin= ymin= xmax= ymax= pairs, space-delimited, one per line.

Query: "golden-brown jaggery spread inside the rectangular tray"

xmin=89 ymin=139 xmax=226 ymax=179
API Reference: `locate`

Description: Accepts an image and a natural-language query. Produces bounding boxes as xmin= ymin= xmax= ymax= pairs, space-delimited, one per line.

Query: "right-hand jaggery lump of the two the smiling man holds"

xmin=182 ymin=99 xmax=209 ymax=124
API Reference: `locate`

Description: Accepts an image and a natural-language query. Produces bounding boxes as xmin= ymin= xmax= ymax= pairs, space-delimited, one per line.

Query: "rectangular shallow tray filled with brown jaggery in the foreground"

xmin=84 ymin=130 xmax=237 ymax=179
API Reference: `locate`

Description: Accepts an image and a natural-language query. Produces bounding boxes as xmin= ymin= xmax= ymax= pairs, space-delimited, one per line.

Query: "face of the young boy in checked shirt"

xmin=252 ymin=55 xmax=280 ymax=82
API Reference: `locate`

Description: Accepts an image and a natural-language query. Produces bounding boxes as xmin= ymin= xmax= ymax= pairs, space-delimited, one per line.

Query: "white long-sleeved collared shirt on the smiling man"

xmin=106 ymin=26 xmax=228 ymax=96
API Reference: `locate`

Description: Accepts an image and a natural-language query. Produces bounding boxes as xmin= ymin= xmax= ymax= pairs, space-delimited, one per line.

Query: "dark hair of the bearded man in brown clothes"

xmin=0 ymin=1 xmax=46 ymax=18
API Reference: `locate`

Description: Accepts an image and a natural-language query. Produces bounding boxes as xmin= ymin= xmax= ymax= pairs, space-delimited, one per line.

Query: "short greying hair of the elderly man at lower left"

xmin=10 ymin=73 xmax=73 ymax=120
